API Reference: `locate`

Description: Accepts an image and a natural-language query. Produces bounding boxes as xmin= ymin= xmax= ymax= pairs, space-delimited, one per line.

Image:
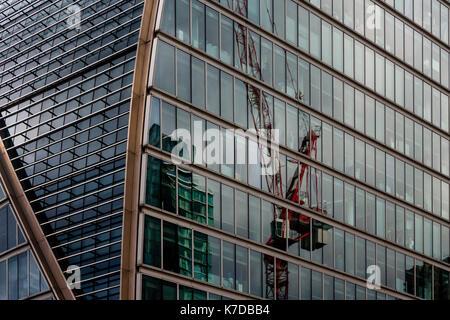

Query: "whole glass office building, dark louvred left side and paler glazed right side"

xmin=0 ymin=0 xmax=450 ymax=300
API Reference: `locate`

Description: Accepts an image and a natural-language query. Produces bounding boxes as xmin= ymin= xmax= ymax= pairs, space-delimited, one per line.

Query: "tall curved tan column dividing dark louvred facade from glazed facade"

xmin=120 ymin=0 xmax=159 ymax=300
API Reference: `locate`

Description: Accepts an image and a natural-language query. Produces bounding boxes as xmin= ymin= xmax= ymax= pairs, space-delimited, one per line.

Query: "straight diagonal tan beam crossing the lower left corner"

xmin=0 ymin=139 xmax=75 ymax=300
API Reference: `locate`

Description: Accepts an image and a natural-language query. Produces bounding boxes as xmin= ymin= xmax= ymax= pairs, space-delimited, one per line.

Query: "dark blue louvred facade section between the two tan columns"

xmin=0 ymin=0 xmax=143 ymax=299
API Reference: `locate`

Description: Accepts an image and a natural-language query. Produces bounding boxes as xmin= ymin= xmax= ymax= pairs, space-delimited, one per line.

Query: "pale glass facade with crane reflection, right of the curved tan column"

xmin=142 ymin=0 xmax=450 ymax=300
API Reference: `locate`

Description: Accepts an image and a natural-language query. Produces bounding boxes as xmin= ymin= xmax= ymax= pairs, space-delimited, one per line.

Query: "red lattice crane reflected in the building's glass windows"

xmin=228 ymin=0 xmax=323 ymax=300
